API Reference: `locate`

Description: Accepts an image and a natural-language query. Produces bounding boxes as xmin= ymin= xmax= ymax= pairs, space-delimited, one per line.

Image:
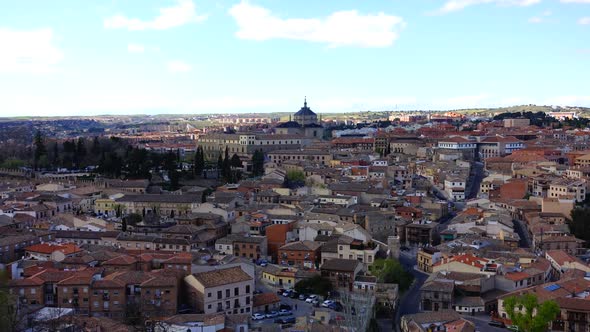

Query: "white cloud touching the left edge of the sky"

xmin=0 ymin=28 xmax=63 ymax=73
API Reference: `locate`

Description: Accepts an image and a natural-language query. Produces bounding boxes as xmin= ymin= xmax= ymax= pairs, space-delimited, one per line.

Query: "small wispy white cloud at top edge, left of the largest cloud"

xmin=104 ymin=0 xmax=207 ymax=30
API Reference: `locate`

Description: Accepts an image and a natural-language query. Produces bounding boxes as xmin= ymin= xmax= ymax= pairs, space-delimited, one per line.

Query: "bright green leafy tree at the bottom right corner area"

xmin=504 ymin=294 xmax=559 ymax=332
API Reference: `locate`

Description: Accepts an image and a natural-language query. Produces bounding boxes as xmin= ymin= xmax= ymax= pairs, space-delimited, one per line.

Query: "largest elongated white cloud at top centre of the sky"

xmin=229 ymin=1 xmax=406 ymax=47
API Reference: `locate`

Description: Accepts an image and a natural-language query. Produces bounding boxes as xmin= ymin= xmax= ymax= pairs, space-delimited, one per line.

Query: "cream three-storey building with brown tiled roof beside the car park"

xmin=184 ymin=266 xmax=254 ymax=315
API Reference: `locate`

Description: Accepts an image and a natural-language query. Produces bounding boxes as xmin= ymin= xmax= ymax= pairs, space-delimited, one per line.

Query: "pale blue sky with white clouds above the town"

xmin=0 ymin=0 xmax=590 ymax=116
